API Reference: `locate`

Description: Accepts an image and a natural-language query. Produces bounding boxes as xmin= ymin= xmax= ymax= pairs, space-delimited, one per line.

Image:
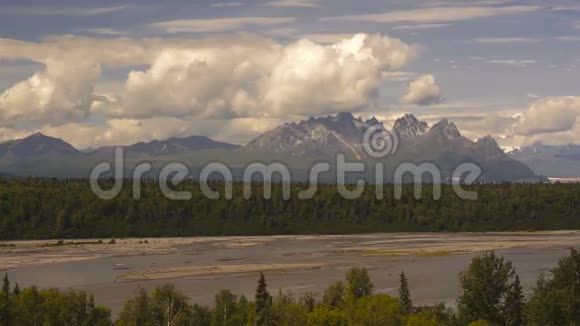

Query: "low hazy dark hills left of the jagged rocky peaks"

xmin=0 ymin=133 xmax=239 ymax=178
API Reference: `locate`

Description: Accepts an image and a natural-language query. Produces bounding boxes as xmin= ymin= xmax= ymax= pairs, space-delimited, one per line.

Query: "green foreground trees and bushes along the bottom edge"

xmin=0 ymin=249 xmax=580 ymax=326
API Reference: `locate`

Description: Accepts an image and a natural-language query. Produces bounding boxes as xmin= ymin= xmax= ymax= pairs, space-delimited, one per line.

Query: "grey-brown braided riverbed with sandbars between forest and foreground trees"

xmin=0 ymin=231 xmax=580 ymax=313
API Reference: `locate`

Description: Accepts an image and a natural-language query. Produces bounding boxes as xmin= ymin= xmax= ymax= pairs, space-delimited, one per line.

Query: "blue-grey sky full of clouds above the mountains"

xmin=0 ymin=0 xmax=580 ymax=149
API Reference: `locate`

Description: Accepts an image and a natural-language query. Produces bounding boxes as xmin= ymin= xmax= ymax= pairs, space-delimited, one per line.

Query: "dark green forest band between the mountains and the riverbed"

xmin=0 ymin=177 xmax=580 ymax=240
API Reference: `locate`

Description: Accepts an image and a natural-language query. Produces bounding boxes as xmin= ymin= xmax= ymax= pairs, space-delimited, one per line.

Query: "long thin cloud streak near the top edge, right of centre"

xmin=322 ymin=6 xmax=542 ymax=23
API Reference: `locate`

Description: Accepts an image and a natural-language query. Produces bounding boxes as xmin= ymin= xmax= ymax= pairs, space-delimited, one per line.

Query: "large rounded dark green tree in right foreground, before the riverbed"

xmin=457 ymin=252 xmax=515 ymax=324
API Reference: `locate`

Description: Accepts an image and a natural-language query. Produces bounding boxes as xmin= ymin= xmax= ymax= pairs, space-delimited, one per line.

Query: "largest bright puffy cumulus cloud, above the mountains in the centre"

xmin=92 ymin=34 xmax=417 ymax=119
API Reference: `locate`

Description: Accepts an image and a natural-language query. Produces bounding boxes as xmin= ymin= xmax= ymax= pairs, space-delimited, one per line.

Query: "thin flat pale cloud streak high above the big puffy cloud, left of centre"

xmin=151 ymin=17 xmax=295 ymax=33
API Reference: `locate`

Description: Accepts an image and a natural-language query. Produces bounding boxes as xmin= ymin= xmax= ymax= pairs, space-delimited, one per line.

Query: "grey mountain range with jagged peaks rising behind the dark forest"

xmin=0 ymin=113 xmax=556 ymax=181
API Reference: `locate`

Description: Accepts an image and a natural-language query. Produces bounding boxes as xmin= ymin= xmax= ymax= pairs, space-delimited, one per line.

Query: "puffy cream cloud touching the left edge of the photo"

xmin=0 ymin=35 xmax=165 ymax=128
